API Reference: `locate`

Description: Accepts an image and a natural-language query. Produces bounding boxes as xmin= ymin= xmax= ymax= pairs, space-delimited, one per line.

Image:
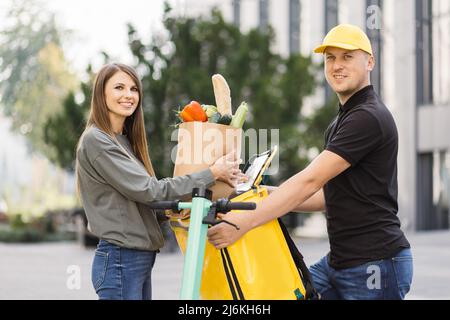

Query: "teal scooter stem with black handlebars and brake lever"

xmin=150 ymin=188 xmax=256 ymax=300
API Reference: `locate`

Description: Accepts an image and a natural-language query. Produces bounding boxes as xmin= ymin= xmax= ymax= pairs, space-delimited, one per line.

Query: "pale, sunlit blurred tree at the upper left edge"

xmin=0 ymin=0 xmax=77 ymax=155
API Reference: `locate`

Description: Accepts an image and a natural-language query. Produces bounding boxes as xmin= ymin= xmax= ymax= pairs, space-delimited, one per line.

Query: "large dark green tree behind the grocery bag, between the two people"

xmin=129 ymin=5 xmax=315 ymax=182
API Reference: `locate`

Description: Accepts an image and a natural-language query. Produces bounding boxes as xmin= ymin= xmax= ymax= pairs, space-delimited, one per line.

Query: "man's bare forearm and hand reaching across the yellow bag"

xmin=208 ymin=150 xmax=350 ymax=249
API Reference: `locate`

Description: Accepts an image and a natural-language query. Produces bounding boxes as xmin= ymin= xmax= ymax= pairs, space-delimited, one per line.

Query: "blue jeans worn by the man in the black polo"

xmin=309 ymin=248 xmax=413 ymax=300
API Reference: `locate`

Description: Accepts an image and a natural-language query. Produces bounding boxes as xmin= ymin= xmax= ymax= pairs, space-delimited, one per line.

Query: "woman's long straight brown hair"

xmin=77 ymin=63 xmax=155 ymax=195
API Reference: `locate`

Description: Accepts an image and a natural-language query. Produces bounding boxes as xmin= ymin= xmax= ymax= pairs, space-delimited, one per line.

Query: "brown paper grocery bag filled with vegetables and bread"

xmin=173 ymin=121 xmax=242 ymax=200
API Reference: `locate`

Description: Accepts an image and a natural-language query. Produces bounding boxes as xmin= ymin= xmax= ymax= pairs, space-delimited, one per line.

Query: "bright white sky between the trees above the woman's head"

xmin=41 ymin=0 xmax=169 ymax=73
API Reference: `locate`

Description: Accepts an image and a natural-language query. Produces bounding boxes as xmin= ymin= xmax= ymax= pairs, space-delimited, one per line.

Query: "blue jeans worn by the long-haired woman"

xmin=92 ymin=240 xmax=156 ymax=300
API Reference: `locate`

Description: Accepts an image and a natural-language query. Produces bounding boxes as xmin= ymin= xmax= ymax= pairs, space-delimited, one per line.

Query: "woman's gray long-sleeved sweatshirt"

xmin=77 ymin=127 xmax=215 ymax=250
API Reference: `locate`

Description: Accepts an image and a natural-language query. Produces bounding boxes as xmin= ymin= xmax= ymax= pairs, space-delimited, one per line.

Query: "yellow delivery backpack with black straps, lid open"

xmin=170 ymin=148 xmax=317 ymax=300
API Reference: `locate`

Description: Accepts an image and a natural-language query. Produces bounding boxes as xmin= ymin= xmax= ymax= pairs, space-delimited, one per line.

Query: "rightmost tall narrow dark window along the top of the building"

xmin=416 ymin=0 xmax=433 ymax=106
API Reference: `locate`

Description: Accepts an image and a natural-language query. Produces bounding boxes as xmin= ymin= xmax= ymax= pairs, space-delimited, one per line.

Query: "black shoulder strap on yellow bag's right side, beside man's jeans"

xmin=278 ymin=219 xmax=320 ymax=300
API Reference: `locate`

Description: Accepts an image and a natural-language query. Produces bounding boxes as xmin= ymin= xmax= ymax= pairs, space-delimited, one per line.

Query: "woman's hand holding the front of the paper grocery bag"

xmin=210 ymin=151 xmax=247 ymax=188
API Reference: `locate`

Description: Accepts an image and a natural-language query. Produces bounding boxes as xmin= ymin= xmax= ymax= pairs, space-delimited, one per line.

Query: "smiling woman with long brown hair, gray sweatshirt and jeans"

xmin=76 ymin=63 xmax=241 ymax=300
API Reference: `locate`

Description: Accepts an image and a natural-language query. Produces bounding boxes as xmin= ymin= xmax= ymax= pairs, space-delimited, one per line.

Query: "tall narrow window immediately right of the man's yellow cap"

xmin=366 ymin=0 xmax=383 ymax=96
